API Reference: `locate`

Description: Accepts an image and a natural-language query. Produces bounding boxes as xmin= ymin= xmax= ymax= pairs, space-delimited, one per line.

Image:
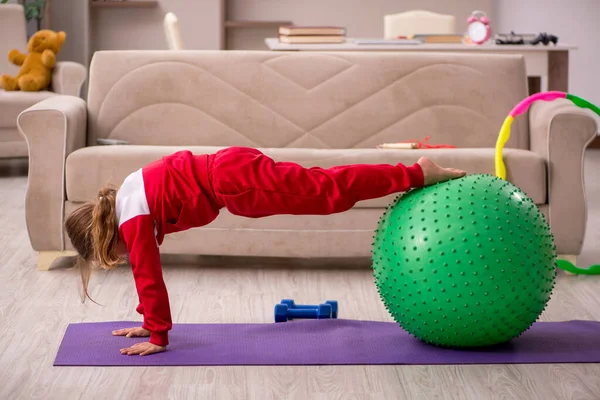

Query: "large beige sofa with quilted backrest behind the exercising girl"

xmin=18 ymin=51 xmax=596 ymax=269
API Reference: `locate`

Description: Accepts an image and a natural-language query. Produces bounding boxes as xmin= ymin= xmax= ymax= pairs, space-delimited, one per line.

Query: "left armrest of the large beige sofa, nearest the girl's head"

xmin=17 ymin=96 xmax=87 ymax=251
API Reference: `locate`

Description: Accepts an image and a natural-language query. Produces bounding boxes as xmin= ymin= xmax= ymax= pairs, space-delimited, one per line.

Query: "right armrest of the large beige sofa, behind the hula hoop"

xmin=529 ymin=100 xmax=598 ymax=255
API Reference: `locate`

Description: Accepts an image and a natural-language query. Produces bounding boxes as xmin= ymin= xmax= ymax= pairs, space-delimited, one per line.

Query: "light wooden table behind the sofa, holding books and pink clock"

xmin=265 ymin=38 xmax=577 ymax=94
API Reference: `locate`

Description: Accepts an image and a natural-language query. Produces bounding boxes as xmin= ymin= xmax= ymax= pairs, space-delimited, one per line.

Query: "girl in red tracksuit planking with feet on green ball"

xmin=65 ymin=147 xmax=465 ymax=355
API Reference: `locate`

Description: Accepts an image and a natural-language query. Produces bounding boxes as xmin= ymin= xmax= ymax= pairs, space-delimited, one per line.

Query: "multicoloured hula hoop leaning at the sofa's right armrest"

xmin=495 ymin=91 xmax=600 ymax=275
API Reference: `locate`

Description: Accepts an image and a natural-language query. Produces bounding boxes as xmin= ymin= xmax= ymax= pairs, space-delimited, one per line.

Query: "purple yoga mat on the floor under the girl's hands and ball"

xmin=54 ymin=319 xmax=600 ymax=366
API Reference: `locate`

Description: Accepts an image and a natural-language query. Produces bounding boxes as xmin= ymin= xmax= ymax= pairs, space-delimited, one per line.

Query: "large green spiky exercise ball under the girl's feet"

xmin=372 ymin=174 xmax=556 ymax=348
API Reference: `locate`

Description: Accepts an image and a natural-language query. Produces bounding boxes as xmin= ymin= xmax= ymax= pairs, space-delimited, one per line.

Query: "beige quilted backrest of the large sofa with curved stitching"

xmin=88 ymin=50 xmax=529 ymax=149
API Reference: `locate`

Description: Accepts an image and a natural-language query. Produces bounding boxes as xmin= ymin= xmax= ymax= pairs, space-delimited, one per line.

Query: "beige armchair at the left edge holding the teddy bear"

xmin=0 ymin=4 xmax=87 ymax=158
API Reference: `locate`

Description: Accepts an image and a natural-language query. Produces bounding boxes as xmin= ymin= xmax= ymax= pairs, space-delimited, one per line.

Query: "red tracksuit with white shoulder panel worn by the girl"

xmin=116 ymin=147 xmax=423 ymax=346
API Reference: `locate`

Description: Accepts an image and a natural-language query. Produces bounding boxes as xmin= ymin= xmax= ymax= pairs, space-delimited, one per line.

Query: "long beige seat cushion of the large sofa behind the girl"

xmin=66 ymin=145 xmax=546 ymax=208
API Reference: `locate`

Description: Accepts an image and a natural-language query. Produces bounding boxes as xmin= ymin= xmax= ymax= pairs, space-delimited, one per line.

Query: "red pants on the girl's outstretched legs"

xmin=210 ymin=147 xmax=423 ymax=218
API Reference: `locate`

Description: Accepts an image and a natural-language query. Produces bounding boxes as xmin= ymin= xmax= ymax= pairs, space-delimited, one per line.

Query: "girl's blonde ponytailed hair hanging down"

xmin=65 ymin=187 xmax=125 ymax=302
